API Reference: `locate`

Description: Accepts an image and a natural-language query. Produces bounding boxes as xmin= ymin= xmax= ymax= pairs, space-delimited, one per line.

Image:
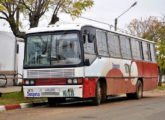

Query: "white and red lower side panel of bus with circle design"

xmin=85 ymin=57 xmax=158 ymax=95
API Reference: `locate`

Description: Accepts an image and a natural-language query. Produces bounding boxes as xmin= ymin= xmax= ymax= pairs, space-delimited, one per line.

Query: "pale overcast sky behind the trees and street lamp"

xmin=0 ymin=0 xmax=165 ymax=30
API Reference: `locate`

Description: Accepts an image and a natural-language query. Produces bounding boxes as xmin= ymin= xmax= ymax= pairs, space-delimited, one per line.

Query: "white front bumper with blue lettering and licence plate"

xmin=23 ymin=85 xmax=83 ymax=98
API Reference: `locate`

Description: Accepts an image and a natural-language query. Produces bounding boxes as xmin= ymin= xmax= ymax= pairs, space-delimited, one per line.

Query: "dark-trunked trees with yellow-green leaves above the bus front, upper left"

xmin=0 ymin=0 xmax=94 ymax=38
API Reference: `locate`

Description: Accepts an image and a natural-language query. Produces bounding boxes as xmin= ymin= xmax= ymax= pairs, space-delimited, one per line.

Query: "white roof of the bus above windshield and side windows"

xmin=26 ymin=24 xmax=154 ymax=43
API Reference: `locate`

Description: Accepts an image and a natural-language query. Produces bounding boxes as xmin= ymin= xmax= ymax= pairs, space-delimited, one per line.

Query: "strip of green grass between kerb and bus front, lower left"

xmin=0 ymin=92 xmax=46 ymax=105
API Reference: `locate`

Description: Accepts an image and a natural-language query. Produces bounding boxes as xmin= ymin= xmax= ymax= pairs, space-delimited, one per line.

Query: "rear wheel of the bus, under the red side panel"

xmin=135 ymin=80 xmax=143 ymax=99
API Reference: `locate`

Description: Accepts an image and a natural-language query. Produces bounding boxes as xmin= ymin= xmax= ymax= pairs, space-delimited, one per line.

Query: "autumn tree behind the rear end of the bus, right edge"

xmin=127 ymin=16 xmax=165 ymax=86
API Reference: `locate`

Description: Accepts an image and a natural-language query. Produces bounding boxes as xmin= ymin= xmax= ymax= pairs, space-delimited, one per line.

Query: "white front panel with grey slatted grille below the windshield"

xmin=24 ymin=67 xmax=84 ymax=79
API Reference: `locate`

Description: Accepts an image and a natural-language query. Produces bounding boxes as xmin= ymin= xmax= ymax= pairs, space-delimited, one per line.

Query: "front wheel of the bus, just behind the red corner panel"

xmin=93 ymin=81 xmax=102 ymax=106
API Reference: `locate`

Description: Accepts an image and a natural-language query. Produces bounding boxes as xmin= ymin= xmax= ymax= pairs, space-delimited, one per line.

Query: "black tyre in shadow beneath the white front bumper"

xmin=48 ymin=98 xmax=66 ymax=107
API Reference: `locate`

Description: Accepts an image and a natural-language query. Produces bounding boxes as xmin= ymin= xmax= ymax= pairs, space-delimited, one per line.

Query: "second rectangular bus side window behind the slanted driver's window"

xmin=108 ymin=32 xmax=121 ymax=57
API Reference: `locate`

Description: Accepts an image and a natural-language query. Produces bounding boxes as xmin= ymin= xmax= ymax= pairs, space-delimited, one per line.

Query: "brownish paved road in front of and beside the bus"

xmin=0 ymin=92 xmax=165 ymax=120
